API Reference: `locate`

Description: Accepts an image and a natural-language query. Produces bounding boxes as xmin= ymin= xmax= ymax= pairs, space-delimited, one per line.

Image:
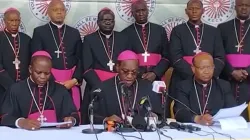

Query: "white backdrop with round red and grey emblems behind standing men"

xmin=0 ymin=0 xmax=235 ymax=40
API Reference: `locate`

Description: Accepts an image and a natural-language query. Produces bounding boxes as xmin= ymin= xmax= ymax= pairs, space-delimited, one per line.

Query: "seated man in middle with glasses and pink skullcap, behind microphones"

xmin=92 ymin=50 xmax=163 ymax=123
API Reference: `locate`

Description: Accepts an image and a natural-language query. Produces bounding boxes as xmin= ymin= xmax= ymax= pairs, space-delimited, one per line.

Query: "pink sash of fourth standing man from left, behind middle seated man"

xmin=137 ymin=53 xmax=161 ymax=66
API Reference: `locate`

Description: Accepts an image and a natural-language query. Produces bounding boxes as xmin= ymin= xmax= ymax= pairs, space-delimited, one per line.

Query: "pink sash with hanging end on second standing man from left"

xmin=51 ymin=67 xmax=81 ymax=110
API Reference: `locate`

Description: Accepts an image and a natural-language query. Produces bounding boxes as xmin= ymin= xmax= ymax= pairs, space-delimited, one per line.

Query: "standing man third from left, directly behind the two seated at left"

xmin=81 ymin=8 xmax=129 ymax=123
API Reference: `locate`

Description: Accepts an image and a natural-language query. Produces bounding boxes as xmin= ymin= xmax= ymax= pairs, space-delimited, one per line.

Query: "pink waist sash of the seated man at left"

xmin=28 ymin=110 xmax=57 ymax=122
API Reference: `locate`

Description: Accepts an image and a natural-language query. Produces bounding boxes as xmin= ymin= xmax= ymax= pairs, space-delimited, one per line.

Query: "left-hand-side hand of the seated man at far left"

xmin=17 ymin=119 xmax=41 ymax=130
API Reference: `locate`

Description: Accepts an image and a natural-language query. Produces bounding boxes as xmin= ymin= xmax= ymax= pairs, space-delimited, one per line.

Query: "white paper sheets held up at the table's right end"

xmin=213 ymin=103 xmax=248 ymax=130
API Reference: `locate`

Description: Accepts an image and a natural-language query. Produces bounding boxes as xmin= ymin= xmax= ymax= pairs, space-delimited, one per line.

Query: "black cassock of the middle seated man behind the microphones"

xmin=93 ymin=76 xmax=162 ymax=124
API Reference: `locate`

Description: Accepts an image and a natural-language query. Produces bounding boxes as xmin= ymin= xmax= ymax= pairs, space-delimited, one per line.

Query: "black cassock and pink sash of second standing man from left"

xmin=31 ymin=22 xmax=83 ymax=109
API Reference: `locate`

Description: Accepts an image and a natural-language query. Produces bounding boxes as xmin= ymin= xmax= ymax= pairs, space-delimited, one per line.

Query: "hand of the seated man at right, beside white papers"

xmin=194 ymin=114 xmax=213 ymax=126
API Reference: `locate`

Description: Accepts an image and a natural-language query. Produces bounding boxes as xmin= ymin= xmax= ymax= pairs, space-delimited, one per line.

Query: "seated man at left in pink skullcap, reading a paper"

xmin=1 ymin=51 xmax=79 ymax=130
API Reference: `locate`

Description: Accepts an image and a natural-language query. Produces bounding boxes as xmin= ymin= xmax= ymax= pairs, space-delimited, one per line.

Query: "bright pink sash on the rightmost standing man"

xmin=226 ymin=54 xmax=250 ymax=68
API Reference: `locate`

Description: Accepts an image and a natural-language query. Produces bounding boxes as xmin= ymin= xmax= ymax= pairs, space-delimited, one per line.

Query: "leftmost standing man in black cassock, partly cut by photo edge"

xmin=0 ymin=8 xmax=31 ymax=106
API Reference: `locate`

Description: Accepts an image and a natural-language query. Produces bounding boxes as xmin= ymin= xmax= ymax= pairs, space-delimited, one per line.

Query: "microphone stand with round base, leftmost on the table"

xmin=82 ymin=96 xmax=104 ymax=134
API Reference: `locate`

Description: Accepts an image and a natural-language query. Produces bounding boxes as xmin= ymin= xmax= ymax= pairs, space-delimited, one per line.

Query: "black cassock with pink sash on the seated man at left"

xmin=1 ymin=78 xmax=79 ymax=127
